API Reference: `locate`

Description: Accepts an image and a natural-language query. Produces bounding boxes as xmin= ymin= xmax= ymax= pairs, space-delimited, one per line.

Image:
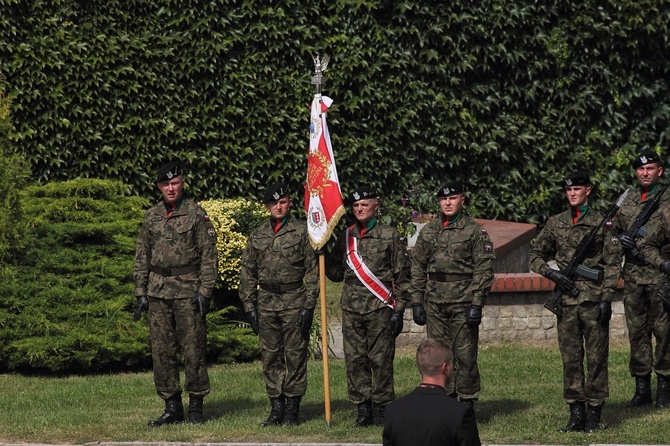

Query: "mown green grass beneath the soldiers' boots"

xmin=0 ymin=345 xmax=670 ymax=445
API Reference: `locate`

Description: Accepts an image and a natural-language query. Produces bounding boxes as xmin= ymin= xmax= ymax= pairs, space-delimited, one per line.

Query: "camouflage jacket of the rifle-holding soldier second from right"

xmin=530 ymin=209 xmax=621 ymax=305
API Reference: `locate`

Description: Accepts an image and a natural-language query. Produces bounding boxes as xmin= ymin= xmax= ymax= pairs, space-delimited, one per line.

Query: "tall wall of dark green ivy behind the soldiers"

xmin=0 ymin=0 xmax=670 ymax=222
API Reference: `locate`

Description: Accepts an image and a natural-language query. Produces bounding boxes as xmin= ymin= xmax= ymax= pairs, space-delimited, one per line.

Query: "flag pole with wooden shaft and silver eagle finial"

xmin=312 ymin=54 xmax=331 ymax=427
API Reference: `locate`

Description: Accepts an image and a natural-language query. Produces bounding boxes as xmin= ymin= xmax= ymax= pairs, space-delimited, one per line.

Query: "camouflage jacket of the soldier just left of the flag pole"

xmin=239 ymin=217 xmax=319 ymax=312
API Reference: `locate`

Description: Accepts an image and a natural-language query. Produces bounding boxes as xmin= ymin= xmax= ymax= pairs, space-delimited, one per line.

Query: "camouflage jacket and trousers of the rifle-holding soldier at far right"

xmin=614 ymin=187 xmax=670 ymax=376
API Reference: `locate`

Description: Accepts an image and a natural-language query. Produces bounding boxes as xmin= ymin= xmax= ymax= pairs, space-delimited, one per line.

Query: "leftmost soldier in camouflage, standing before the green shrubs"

xmin=133 ymin=162 xmax=217 ymax=427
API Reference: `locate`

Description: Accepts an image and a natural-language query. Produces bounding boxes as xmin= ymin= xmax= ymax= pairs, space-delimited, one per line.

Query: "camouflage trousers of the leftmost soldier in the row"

xmin=149 ymin=297 xmax=209 ymax=399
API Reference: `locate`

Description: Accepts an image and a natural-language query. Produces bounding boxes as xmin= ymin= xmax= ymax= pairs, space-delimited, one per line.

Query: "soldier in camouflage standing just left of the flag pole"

xmin=239 ymin=183 xmax=319 ymax=427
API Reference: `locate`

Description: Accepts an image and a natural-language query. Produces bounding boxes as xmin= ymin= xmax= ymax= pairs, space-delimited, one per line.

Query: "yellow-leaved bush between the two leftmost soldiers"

xmin=199 ymin=198 xmax=270 ymax=290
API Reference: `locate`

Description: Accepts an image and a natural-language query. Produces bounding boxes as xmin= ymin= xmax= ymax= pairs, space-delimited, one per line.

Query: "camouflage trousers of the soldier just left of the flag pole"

xmin=258 ymin=308 xmax=308 ymax=398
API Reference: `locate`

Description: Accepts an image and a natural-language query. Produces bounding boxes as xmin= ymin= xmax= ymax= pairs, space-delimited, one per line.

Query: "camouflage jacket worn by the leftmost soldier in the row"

xmin=133 ymin=198 xmax=217 ymax=299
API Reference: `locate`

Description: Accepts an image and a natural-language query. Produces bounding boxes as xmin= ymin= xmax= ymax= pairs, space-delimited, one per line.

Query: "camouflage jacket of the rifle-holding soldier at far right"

xmin=613 ymin=186 xmax=669 ymax=285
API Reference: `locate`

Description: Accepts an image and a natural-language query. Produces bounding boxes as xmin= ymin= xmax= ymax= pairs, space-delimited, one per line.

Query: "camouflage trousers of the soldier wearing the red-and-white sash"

xmin=342 ymin=306 xmax=395 ymax=404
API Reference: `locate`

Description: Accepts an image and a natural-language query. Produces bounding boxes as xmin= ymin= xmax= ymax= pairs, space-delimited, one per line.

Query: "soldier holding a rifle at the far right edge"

xmin=614 ymin=150 xmax=670 ymax=407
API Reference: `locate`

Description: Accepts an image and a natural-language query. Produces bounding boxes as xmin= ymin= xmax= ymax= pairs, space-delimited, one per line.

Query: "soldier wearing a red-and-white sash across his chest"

xmin=326 ymin=186 xmax=409 ymax=427
